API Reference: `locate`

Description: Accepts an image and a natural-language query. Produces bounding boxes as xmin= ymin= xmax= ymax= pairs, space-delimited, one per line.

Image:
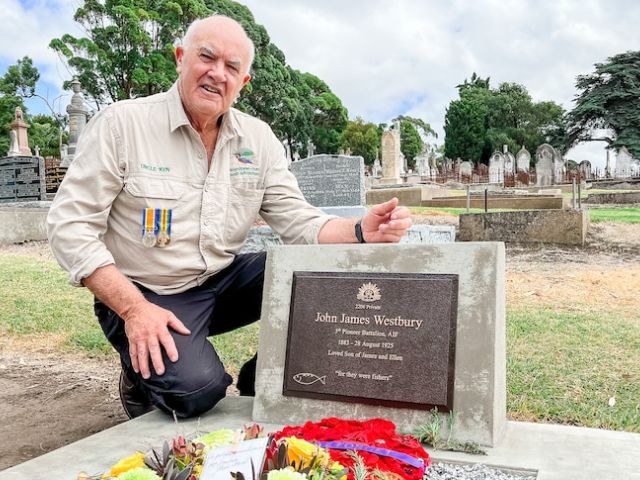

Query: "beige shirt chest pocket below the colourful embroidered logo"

xmin=224 ymin=187 xmax=264 ymax=251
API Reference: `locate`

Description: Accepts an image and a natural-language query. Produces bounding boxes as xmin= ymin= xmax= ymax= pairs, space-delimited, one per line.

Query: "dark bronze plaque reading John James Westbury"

xmin=283 ymin=272 xmax=458 ymax=411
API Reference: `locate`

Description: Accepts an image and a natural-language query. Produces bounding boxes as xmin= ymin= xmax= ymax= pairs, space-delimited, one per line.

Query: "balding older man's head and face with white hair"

xmin=176 ymin=21 xmax=251 ymax=123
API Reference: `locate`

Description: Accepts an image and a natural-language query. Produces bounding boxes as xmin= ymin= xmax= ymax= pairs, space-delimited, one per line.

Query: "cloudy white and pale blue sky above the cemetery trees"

xmin=0 ymin=0 xmax=640 ymax=166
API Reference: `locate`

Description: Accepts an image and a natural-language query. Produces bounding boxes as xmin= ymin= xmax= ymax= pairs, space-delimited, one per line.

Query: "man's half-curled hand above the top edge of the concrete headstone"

xmin=361 ymin=198 xmax=412 ymax=243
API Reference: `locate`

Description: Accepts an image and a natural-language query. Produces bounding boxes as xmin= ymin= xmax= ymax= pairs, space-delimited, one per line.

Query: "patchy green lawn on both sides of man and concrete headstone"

xmin=0 ymin=255 xmax=640 ymax=432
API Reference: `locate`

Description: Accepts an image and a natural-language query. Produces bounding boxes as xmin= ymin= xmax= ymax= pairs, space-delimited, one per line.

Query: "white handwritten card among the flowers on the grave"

xmin=200 ymin=437 xmax=269 ymax=480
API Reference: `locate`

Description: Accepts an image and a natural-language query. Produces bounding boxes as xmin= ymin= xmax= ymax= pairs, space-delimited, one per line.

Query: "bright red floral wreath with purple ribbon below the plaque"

xmin=275 ymin=418 xmax=431 ymax=480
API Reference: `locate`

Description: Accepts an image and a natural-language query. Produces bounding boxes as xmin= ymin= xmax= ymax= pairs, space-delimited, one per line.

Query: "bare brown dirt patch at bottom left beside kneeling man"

xmin=0 ymin=338 xmax=126 ymax=470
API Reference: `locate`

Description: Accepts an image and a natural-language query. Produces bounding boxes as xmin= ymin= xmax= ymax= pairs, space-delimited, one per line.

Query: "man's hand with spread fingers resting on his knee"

xmin=123 ymin=300 xmax=191 ymax=379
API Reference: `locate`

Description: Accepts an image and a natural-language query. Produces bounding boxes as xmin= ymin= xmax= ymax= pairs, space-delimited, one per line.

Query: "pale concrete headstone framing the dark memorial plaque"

xmin=253 ymin=243 xmax=506 ymax=445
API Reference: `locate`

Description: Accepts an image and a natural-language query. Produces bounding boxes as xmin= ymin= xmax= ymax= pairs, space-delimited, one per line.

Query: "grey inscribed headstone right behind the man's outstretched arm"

xmin=291 ymin=155 xmax=366 ymax=211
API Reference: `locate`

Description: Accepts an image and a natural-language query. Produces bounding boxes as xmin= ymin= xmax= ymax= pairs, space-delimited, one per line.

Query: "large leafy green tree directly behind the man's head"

xmin=50 ymin=0 xmax=346 ymax=154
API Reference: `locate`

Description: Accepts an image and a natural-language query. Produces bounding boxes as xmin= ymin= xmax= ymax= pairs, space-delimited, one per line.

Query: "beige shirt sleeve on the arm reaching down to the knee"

xmin=47 ymin=109 xmax=125 ymax=286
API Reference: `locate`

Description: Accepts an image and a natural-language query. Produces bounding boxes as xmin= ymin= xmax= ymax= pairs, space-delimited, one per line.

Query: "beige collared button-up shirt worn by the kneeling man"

xmin=47 ymin=84 xmax=332 ymax=294
